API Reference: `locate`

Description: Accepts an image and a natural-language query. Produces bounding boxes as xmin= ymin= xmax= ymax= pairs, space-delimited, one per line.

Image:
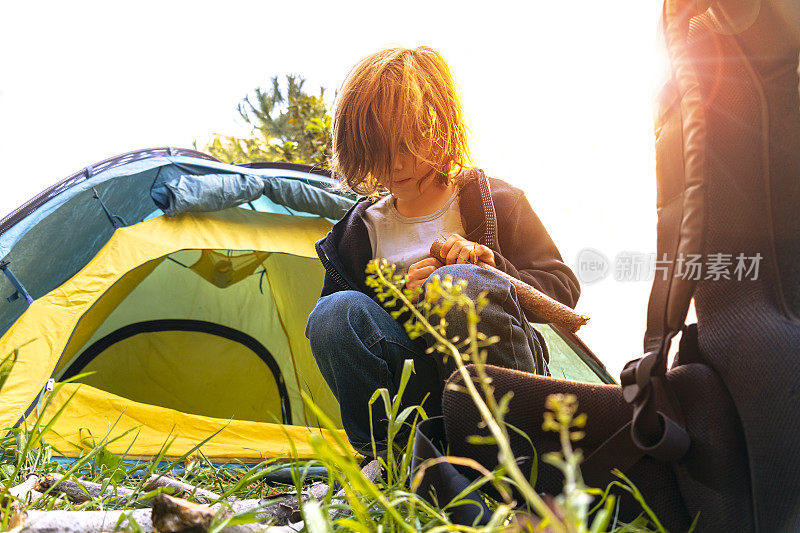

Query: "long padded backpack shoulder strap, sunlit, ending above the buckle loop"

xmin=644 ymin=0 xmax=708 ymax=362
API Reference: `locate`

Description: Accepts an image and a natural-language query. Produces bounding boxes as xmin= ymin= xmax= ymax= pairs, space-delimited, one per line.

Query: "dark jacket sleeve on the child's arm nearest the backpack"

xmin=495 ymin=191 xmax=581 ymax=314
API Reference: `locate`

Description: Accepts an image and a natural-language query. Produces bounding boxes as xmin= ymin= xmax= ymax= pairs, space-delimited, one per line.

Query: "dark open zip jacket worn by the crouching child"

xmin=316 ymin=168 xmax=580 ymax=322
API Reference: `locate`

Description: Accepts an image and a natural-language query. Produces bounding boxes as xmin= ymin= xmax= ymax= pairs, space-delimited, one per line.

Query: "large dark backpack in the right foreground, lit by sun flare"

xmin=417 ymin=0 xmax=800 ymax=531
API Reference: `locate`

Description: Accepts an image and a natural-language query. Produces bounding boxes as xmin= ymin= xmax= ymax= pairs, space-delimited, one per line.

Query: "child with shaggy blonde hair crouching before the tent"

xmin=306 ymin=47 xmax=580 ymax=452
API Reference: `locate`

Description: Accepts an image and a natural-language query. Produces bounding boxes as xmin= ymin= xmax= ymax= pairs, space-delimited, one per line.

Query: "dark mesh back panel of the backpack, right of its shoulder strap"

xmin=693 ymin=4 xmax=800 ymax=531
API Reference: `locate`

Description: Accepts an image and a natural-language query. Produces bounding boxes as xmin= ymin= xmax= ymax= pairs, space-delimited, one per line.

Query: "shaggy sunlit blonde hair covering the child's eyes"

xmin=332 ymin=46 xmax=469 ymax=195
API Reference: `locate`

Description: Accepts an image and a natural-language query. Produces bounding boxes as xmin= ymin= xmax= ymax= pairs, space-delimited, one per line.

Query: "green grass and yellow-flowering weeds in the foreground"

xmin=0 ymin=262 xmax=676 ymax=533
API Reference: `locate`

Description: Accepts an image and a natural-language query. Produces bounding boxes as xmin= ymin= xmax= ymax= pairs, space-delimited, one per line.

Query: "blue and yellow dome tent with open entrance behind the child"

xmin=0 ymin=148 xmax=610 ymax=461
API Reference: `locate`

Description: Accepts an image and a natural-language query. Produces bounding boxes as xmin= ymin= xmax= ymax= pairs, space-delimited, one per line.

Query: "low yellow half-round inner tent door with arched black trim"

xmin=61 ymin=319 xmax=292 ymax=424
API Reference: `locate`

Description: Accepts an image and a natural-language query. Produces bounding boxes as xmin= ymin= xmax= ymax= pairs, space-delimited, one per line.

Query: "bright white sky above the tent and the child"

xmin=0 ymin=0 xmax=663 ymax=376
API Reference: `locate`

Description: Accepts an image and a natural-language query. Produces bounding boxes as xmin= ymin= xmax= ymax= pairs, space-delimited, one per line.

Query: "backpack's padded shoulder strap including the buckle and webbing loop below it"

xmin=612 ymin=0 xmax=707 ymax=461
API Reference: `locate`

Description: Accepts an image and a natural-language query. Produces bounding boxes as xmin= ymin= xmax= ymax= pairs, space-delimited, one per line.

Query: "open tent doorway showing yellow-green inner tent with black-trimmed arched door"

xmin=54 ymin=248 xmax=340 ymax=432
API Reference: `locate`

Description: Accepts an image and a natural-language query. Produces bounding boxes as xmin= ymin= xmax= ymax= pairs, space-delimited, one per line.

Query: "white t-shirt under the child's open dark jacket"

xmin=364 ymin=191 xmax=464 ymax=275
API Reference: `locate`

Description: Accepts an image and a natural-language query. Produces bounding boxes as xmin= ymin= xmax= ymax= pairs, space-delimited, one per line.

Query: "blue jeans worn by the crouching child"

xmin=306 ymin=265 xmax=547 ymax=451
